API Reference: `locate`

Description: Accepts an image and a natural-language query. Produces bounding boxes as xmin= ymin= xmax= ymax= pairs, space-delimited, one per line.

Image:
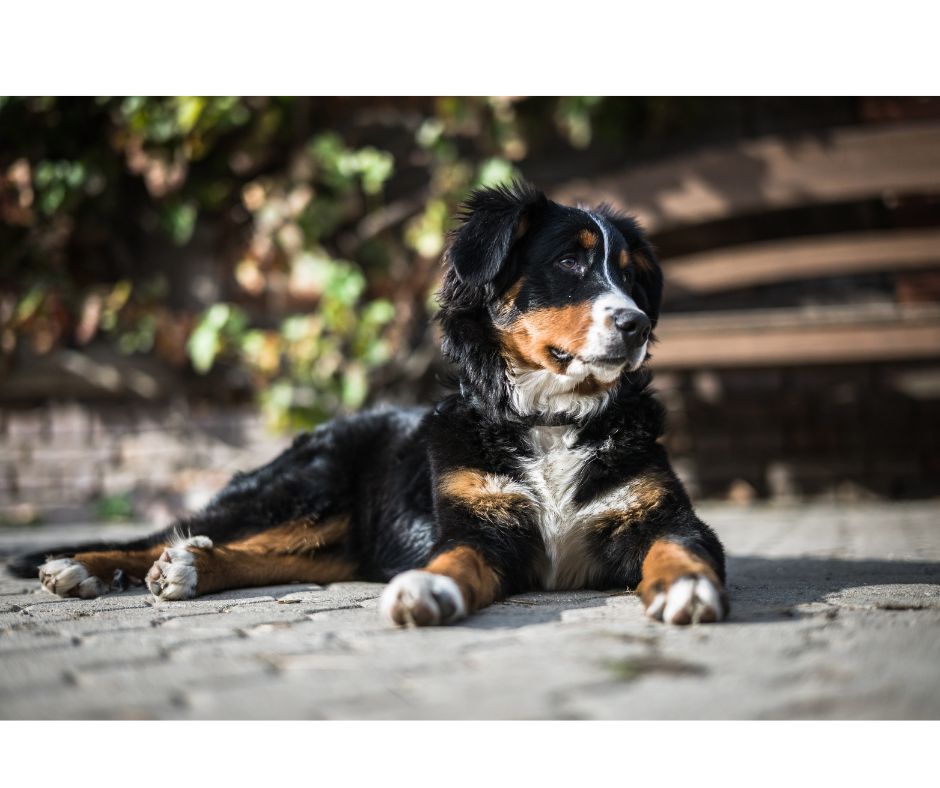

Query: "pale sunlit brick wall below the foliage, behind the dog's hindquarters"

xmin=0 ymin=404 xmax=289 ymax=523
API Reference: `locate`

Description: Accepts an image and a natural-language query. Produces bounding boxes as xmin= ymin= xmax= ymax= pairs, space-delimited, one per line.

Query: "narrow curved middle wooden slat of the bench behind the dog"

xmin=665 ymin=228 xmax=940 ymax=294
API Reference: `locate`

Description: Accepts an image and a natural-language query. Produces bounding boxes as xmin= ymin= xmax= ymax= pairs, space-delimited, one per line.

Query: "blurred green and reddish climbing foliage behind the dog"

xmin=0 ymin=96 xmax=844 ymax=428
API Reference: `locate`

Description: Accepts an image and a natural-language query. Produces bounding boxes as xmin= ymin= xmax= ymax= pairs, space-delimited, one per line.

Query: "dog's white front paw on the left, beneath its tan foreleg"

xmin=379 ymin=569 xmax=467 ymax=627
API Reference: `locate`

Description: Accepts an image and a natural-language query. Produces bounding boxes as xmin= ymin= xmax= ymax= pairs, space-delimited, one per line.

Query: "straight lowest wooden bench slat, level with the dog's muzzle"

xmin=652 ymin=307 xmax=940 ymax=370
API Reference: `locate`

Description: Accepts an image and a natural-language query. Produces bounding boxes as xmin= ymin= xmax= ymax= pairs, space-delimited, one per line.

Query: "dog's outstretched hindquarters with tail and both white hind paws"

xmin=21 ymin=424 xmax=374 ymax=600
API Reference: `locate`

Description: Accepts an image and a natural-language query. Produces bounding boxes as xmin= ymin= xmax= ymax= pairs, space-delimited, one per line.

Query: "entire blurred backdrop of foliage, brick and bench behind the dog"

xmin=0 ymin=97 xmax=940 ymax=525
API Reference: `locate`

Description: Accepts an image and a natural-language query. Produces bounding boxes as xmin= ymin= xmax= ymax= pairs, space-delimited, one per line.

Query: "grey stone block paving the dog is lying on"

xmin=0 ymin=502 xmax=940 ymax=719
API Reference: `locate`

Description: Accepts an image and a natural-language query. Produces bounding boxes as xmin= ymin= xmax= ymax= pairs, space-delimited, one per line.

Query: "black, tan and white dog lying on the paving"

xmin=11 ymin=182 xmax=728 ymax=626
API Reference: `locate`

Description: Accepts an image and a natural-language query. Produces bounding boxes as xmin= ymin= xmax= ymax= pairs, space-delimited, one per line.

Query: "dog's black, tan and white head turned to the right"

xmin=440 ymin=184 xmax=662 ymax=417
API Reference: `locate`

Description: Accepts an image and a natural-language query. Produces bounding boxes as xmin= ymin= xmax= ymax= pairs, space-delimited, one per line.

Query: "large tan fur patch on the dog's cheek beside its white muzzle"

xmin=502 ymin=301 xmax=592 ymax=372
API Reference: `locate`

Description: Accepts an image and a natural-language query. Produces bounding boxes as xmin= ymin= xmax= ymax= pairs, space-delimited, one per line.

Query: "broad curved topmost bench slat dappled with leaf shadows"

xmin=552 ymin=121 xmax=940 ymax=232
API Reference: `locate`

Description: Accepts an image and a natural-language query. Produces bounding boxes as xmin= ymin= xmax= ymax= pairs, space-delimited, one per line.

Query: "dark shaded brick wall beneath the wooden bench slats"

xmin=657 ymin=363 xmax=940 ymax=500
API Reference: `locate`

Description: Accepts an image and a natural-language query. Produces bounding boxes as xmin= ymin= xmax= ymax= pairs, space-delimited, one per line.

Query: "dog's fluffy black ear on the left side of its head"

xmin=447 ymin=181 xmax=546 ymax=286
